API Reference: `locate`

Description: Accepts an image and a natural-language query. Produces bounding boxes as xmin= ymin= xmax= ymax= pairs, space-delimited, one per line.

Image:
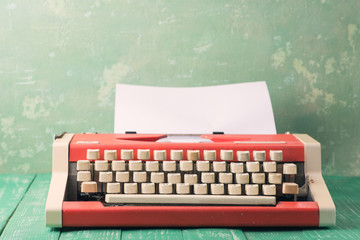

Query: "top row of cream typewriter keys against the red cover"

xmin=86 ymin=149 xmax=283 ymax=162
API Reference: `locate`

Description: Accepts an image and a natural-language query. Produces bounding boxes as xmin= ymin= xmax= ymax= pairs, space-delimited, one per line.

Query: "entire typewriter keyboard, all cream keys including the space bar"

xmin=73 ymin=149 xmax=306 ymax=205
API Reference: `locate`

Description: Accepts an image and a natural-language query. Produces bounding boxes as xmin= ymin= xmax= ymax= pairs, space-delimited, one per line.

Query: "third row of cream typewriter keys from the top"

xmin=77 ymin=171 xmax=283 ymax=185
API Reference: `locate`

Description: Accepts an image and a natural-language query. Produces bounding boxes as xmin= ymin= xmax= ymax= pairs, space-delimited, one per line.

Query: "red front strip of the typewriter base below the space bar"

xmin=62 ymin=201 xmax=319 ymax=227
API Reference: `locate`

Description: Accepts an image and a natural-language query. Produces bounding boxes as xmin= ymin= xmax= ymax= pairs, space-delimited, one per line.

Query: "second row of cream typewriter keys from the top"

xmin=76 ymin=160 xmax=297 ymax=175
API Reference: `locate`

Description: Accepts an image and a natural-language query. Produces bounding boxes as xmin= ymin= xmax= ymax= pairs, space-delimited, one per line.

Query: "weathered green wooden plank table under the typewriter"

xmin=0 ymin=174 xmax=360 ymax=240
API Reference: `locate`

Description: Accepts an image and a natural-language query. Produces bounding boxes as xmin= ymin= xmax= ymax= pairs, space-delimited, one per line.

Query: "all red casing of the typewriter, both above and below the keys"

xmin=62 ymin=134 xmax=319 ymax=227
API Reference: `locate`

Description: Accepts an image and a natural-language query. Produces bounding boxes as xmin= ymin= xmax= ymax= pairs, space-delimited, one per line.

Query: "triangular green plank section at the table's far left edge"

xmin=0 ymin=174 xmax=35 ymax=234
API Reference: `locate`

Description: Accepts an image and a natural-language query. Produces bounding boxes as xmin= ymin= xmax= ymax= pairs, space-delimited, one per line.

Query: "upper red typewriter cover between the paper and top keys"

xmin=69 ymin=134 xmax=304 ymax=162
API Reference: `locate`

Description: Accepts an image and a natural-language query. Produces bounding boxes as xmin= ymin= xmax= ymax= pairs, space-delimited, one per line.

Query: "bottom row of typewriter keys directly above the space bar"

xmin=81 ymin=182 xmax=288 ymax=196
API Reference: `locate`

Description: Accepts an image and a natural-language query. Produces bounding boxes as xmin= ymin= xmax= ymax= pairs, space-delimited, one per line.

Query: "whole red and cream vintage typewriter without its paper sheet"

xmin=46 ymin=133 xmax=335 ymax=227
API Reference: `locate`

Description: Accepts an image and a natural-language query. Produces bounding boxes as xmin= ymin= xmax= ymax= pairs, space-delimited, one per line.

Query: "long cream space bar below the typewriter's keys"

xmin=105 ymin=194 xmax=276 ymax=205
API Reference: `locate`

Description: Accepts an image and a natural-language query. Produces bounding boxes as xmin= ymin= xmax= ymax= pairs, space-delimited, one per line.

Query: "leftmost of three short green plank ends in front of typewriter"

xmin=59 ymin=228 xmax=121 ymax=240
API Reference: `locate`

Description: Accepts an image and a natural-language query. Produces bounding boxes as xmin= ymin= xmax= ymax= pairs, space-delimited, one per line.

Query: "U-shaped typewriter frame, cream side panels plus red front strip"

xmin=46 ymin=133 xmax=336 ymax=227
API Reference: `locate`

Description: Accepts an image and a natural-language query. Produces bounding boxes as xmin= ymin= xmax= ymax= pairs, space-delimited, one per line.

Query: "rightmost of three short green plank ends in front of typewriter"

xmin=182 ymin=228 xmax=246 ymax=240
